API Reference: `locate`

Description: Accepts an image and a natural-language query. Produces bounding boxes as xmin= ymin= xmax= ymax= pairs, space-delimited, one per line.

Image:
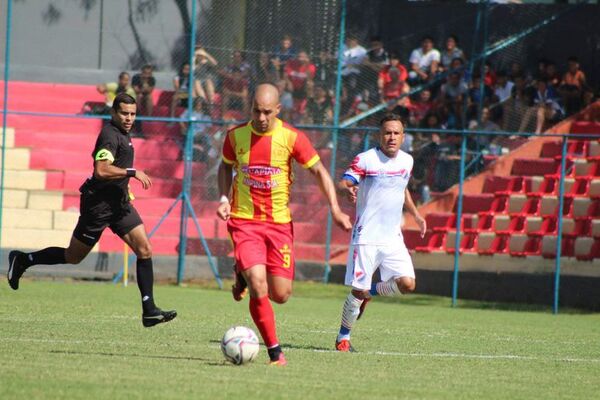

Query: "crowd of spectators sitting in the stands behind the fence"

xmin=98 ymin=35 xmax=594 ymax=200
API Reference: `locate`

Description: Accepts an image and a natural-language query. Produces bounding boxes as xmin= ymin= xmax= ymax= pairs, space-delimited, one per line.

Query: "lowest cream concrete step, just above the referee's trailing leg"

xmin=2 ymin=227 xmax=73 ymax=249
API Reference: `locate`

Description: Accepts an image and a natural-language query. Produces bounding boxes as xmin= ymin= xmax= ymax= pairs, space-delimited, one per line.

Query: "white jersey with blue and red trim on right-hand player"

xmin=343 ymin=147 xmax=413 ymax=245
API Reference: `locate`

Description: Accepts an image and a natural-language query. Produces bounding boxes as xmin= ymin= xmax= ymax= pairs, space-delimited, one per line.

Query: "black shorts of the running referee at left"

xmin=73 ymin=193 xmax=143 ymax=246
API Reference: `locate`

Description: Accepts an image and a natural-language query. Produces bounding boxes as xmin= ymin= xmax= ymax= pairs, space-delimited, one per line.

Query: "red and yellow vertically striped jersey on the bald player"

xmin=223 ymin=119 xmax=319 ymax=224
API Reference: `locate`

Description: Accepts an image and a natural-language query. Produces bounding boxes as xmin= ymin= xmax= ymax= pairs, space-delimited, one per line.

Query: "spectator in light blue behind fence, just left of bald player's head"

xmin=179 ymin=97 xmax=219 ymax=164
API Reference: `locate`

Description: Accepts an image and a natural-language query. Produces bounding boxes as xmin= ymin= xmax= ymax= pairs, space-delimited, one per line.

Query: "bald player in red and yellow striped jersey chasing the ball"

xmin=217 ymin=84 xmax=352 ymax=365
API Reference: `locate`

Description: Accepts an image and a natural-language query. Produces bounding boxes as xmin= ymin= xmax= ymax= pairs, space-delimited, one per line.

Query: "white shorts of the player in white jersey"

xmin=345 ymin=243 xmax=415 ymax=290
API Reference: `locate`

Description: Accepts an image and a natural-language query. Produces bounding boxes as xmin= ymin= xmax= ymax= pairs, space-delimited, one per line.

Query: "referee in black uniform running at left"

xmin=7 ymin=93 xmax=177 ymax=327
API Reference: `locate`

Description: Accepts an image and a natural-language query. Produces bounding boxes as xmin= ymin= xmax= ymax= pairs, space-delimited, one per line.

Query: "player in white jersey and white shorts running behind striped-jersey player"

xmin=335 ymin=114 xmax=427 ymax=352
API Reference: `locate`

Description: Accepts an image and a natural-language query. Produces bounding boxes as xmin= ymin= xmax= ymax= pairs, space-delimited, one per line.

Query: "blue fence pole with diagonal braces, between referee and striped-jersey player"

xmin=177 ymin=0 xmax=197 ymax=285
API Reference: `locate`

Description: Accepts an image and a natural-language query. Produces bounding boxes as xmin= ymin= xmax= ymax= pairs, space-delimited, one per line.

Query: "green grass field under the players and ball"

xmin=0 ymin=280 xmax=600 ymax=400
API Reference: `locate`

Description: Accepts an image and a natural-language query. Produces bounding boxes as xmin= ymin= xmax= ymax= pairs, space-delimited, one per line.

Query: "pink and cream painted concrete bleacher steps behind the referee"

xmin=0 ymin=82 xmax=338 ymax=262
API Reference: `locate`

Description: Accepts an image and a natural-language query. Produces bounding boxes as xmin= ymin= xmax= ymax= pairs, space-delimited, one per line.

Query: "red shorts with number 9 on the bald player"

xmin=227 ymin=218 xmax=294 ymax=279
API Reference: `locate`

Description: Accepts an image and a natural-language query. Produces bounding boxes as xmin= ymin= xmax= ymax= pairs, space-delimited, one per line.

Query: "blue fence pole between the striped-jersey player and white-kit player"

xmin=323 ymin=0 xmax=346 ymax=283
